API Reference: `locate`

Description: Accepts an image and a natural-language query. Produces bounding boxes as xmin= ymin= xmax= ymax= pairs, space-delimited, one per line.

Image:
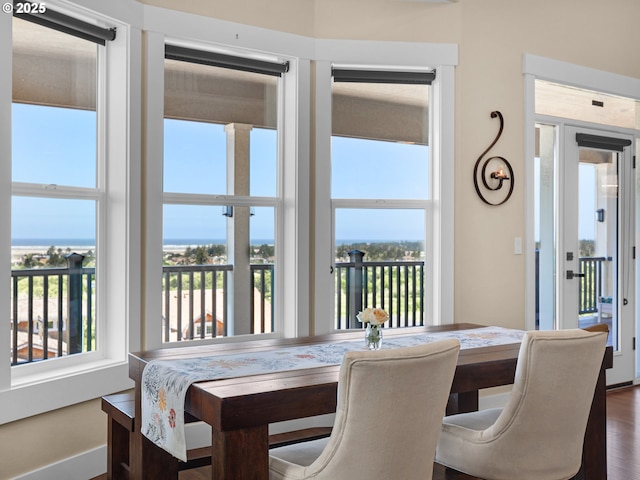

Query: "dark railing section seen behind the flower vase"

xmin=335 ymin=250 xmax=425 ymax=329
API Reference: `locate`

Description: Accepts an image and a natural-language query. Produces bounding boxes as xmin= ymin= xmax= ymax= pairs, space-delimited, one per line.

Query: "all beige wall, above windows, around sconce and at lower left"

xmin=5 ymin=0 xmax=640 ymax=478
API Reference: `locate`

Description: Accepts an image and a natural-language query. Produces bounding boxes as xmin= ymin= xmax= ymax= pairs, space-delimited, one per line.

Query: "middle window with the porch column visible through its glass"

xmin=162 ymin=45 xmax=288 ymax=343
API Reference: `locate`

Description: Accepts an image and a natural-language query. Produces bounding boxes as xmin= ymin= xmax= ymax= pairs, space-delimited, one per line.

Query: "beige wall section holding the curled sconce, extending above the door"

xmin=454 ymin=0 xmax=640 ymax=328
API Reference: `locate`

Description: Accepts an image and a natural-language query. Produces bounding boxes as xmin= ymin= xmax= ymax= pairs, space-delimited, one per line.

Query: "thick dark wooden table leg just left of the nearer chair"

xmin=211 ymin=425 xmax=269 ymax=480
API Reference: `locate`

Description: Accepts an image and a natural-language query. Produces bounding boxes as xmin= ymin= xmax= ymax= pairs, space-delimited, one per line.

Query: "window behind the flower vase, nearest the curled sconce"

xmin=331 ymin=69 xmax=434 ymax=329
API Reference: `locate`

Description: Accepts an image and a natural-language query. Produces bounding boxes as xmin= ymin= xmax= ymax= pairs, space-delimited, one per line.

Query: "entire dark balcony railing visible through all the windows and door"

xmin=11 ymin=250 xmax=611 ymax=365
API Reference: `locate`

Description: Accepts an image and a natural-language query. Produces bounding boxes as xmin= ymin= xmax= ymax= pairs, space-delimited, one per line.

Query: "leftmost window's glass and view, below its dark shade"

xmin=11 ymin=17 xmax=109 ymax=365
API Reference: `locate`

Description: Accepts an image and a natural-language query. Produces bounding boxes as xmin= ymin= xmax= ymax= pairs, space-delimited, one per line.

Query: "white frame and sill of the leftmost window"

xmin=0 ymin=0 xmax=141 ymax=424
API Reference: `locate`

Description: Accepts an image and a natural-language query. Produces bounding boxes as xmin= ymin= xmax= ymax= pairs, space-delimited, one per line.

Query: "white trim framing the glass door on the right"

xmin=522 ymin=54 xmax=640 ymax=330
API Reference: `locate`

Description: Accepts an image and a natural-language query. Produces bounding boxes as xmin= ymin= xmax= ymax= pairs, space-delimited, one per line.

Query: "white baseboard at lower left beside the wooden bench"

xmin=13 ymin=445 xmax=107 ymax=480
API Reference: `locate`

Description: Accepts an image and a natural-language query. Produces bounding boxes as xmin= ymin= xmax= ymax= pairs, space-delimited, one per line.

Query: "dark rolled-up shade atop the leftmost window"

xmin=13 ymin=1 xmax=116 ymax=45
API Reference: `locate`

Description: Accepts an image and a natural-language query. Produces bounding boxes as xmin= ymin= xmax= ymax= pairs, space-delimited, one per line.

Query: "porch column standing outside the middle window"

xmin=225 ymin=123 xmax=253 ymax=336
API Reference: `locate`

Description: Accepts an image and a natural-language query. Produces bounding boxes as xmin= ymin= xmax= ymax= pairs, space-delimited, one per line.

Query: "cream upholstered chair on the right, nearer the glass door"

xmin=436 ymin=329 xmax=607 ymax=480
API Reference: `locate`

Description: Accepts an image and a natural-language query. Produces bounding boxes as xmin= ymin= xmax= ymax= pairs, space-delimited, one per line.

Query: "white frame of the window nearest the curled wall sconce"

xmin=313 ymin=40 xmax=458 ymax=334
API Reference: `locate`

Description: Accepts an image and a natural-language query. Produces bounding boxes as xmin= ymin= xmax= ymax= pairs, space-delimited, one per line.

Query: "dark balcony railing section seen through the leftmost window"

xmin=11 ymin=253 xmax=96 ymax=365
